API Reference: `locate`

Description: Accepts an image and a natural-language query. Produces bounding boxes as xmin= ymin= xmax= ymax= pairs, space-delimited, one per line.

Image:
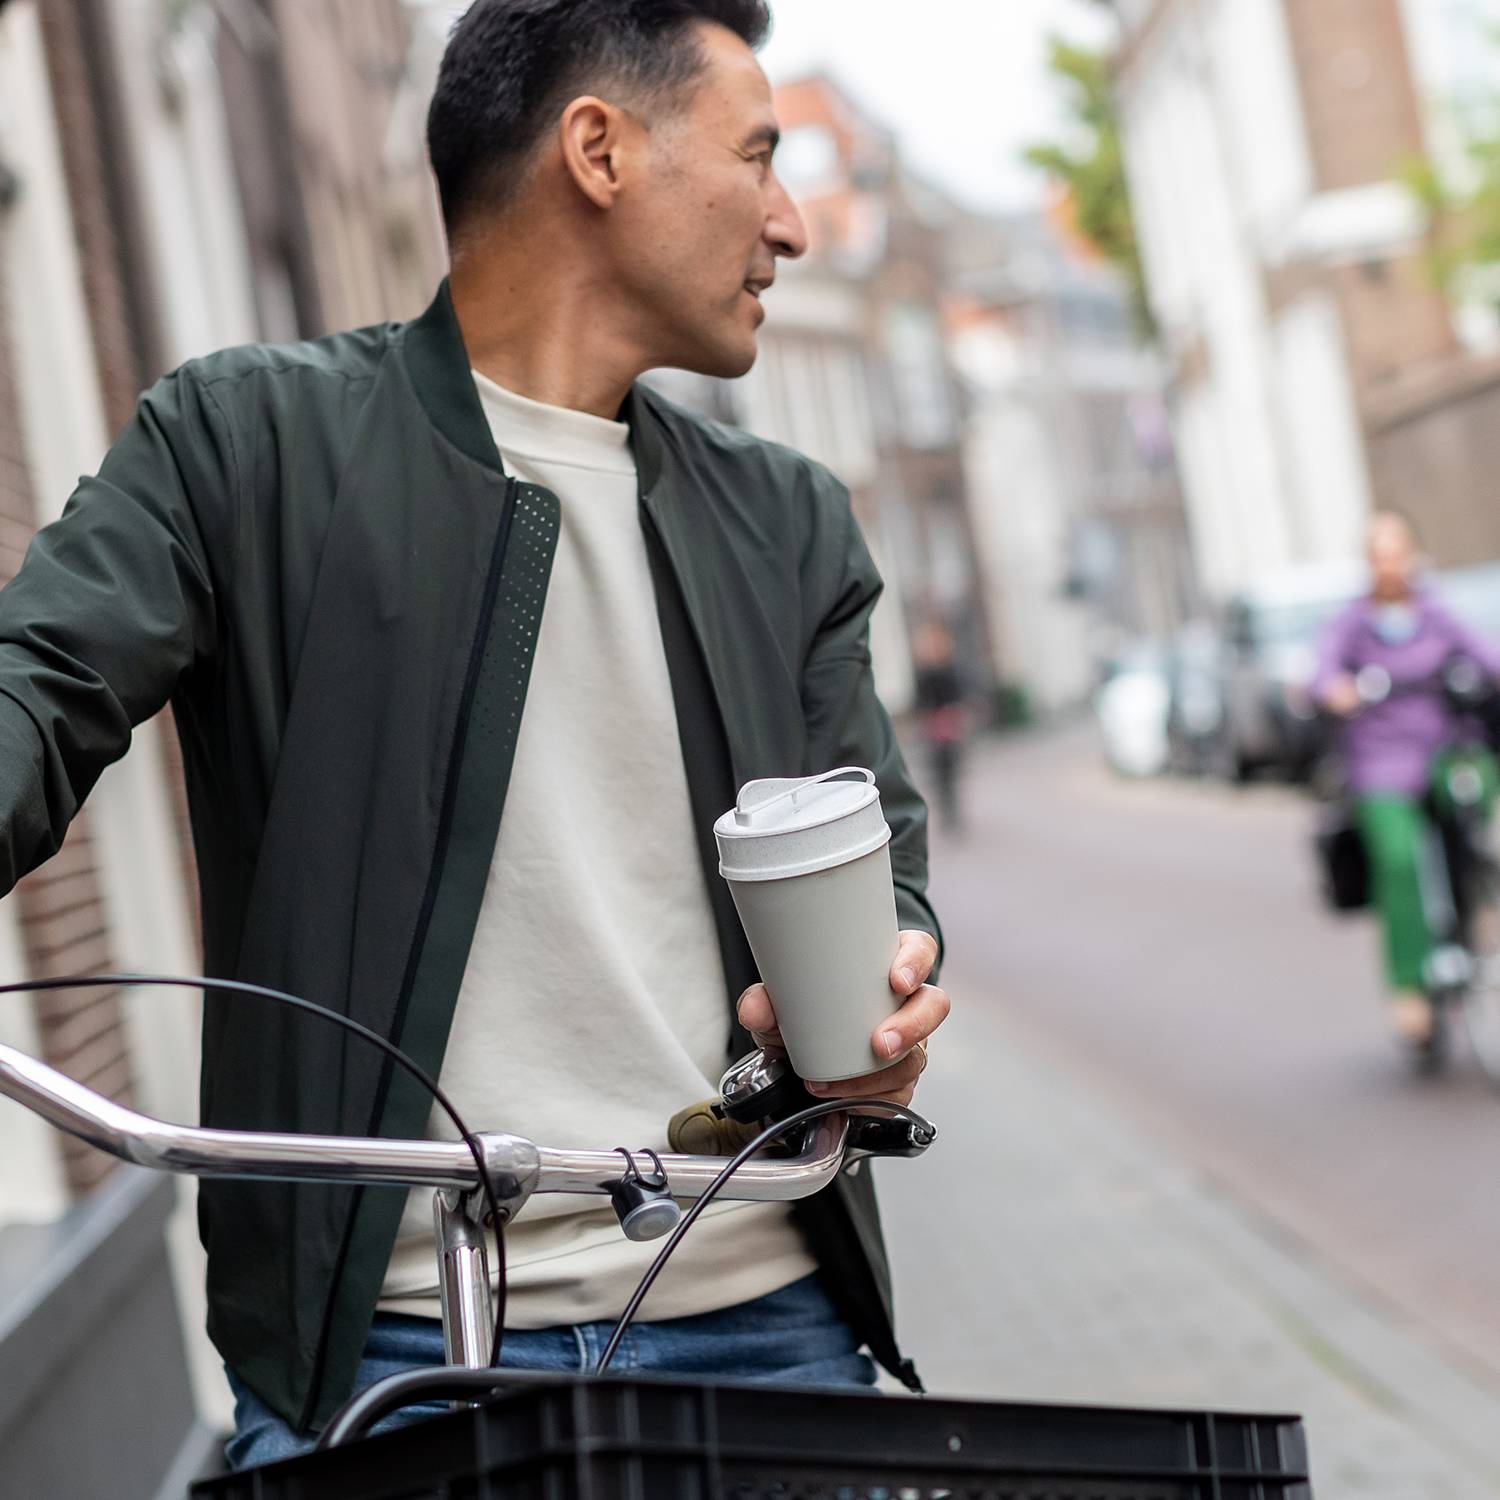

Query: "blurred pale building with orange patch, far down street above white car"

xmin=948 ymin=213 xmax=1197 ymax=714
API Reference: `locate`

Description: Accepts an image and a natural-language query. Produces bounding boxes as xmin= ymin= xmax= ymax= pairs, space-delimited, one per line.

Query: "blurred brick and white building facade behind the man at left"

xmin=0 ymin=0 xmax=446 ymax=1500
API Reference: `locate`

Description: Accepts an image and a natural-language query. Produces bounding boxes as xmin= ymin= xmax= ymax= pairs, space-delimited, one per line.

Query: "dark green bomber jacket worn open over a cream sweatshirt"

xmin=0 ymin=284 xmax=938 ymax=1430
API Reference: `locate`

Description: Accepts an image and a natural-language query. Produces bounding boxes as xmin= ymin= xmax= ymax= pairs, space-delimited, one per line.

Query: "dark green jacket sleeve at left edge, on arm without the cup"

xmin=0 ymin=372 xmax=234 ymax=894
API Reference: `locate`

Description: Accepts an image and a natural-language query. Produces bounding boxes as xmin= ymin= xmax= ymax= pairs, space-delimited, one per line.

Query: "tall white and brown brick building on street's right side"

xmin=1116 ymin=0 xmax=1500 ymax=596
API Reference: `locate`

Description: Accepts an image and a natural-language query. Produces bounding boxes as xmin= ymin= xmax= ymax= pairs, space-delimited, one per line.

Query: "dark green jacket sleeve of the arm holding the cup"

xmin=803 ymin=485 xmax=942 ymax=978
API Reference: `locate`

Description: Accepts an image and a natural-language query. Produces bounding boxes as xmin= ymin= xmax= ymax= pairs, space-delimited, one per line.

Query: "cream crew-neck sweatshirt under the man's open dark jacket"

xmin=381 ymin=374 xmax=816 ymax=1328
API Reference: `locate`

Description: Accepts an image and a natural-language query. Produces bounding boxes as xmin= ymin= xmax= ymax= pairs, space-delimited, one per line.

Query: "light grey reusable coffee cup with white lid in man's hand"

xmin=714 ymin=767 xmax=902 ymax=1082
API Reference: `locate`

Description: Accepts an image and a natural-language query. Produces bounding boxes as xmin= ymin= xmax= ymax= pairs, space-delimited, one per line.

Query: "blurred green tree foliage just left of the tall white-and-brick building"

xmin=1025 ymin=36 xmax=1152 ymax=336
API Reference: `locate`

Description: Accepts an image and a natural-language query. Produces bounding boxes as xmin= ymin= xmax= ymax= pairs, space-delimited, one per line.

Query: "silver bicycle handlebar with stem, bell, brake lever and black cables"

xmin=0 ymin=975 xmax=938 ymax=1386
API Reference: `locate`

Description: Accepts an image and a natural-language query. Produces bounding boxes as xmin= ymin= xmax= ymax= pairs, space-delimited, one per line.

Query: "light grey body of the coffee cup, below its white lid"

xmin=729 ymin=845 xmax=902 ymax=1082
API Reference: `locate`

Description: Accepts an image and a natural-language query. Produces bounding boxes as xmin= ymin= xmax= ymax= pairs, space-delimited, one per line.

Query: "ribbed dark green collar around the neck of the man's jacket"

xmin=404 ymin=276 xmax=663 ymax=495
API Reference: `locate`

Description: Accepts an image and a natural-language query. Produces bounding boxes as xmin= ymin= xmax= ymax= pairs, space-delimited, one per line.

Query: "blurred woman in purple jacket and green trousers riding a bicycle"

xmin=1314 ymin=512 xmax=1500 ymax=1046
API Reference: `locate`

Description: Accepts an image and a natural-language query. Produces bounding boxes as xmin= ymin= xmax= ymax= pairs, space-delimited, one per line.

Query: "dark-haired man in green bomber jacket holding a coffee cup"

xmin=0 ymin=0 xmax=948 ymax=1466
